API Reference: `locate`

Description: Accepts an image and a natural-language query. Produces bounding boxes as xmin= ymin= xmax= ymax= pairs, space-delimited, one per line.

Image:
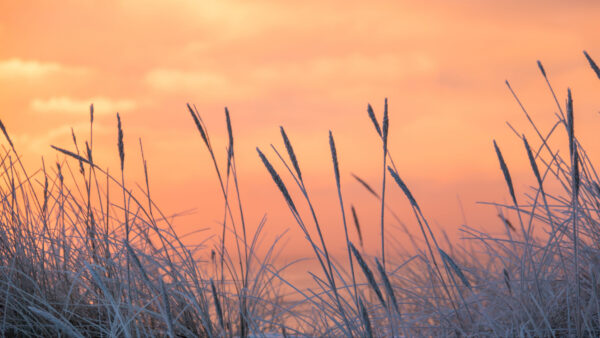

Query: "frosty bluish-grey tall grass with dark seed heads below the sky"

xmin=0 ymin=52 xmax=600 ymax=337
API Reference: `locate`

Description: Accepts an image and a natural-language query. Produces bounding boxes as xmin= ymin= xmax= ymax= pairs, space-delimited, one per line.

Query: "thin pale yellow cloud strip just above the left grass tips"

xmin=30 ymin=97 xmax=137 ymax=114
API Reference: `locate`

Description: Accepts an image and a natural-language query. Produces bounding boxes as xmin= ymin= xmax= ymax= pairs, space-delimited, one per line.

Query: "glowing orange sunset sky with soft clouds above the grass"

xmin=0 ymin=0 xmax=600 ymax=262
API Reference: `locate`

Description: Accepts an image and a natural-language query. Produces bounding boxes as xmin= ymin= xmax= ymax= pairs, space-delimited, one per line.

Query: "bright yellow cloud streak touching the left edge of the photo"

xmin=0 ymin=58 xmax=84 ymax=79
